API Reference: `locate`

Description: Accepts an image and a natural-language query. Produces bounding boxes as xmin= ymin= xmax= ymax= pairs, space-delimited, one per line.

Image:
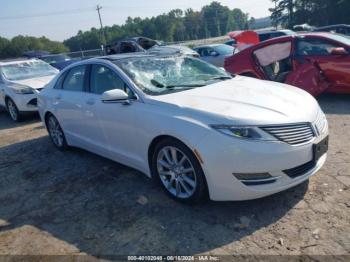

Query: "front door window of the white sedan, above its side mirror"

xmin=90 ymin=65 xmax=129 ymax=94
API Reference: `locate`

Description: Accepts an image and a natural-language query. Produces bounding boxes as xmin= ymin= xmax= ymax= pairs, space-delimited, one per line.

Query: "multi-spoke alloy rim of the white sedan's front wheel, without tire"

xmin=157 ymin=146 xmax=197 ymax=199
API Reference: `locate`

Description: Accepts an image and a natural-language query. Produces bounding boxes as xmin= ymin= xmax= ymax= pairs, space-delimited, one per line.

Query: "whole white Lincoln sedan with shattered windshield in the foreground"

xmin=38 ymin=54 xmax=328 ymax=203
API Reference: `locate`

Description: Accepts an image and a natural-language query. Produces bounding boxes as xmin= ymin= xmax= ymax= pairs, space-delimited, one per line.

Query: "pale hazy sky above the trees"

xmin=0 ymin=0 xmax=272 ymax=41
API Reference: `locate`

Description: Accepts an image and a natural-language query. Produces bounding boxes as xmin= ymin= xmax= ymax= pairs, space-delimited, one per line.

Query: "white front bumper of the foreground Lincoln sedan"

xmin=197 ymin=130 xmax=328 ymax=201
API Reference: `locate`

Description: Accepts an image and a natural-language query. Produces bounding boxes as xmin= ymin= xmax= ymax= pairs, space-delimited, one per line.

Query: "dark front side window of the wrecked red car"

xmin=297 ymin=39 xmax=339 ymax=56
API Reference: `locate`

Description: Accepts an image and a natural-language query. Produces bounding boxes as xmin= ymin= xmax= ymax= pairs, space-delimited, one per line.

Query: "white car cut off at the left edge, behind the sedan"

xmin=0 ymin=59 xmax=59 ymax=121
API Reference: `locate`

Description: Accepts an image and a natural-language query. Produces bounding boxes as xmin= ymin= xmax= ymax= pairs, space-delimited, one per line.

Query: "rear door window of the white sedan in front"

xmin=62 ymin=65 xmax=86 ymax=92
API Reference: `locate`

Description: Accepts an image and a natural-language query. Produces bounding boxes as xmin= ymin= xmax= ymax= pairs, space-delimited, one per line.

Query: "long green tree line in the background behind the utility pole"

xmin=64 ymin=2 xmax=249 ymax=51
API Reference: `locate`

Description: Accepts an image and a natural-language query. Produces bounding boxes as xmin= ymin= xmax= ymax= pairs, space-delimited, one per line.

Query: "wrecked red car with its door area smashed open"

xmin=225 ymin=33 xmax=350 ymax=96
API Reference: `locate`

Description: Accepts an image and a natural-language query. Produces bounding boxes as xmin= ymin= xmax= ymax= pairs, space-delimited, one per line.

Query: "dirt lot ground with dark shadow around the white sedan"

xmin=0 ymin=95 xmax=350 ymax=257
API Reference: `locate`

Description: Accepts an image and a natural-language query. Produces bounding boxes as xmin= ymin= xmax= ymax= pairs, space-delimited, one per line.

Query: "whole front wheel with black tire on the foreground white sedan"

xmin=151 ymin=138 xmax=208 ymax=204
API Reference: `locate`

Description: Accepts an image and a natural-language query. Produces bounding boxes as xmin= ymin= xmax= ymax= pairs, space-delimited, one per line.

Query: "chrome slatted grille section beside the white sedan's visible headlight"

xmin=261 ymin=123 xmax=315 ymax=145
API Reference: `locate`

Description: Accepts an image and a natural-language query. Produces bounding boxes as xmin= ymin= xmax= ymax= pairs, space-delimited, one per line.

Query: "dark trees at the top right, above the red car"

xmin=270 ymin=0 xmax=350 ymax=29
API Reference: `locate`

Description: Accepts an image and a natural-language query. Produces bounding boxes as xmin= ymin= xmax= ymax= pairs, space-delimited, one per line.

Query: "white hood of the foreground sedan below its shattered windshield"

xmin=150 ymin=76 xmax=319 ymax=125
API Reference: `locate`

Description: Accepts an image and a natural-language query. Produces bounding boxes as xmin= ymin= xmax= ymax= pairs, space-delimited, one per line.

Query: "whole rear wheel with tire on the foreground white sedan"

xmin=46 ymin=114 xmax=68 ymax=151
